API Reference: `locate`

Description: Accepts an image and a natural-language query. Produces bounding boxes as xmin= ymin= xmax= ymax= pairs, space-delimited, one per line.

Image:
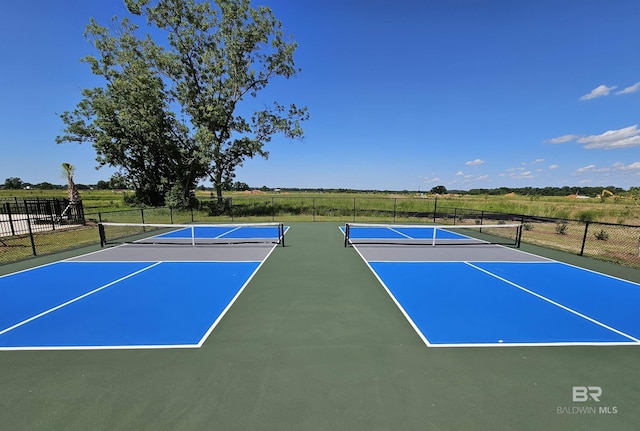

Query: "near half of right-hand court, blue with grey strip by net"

xmin=354 ymin=224 xmax=640 ymax=347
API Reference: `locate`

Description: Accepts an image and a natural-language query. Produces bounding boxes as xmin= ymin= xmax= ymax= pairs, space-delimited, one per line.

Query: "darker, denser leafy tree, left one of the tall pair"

xmin=57 ymin=19 xmax=206 ymax=205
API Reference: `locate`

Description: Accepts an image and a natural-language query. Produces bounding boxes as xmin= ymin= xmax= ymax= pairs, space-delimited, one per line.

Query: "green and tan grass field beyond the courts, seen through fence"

xmin=0 ymin=190 xmax=640 ymax=267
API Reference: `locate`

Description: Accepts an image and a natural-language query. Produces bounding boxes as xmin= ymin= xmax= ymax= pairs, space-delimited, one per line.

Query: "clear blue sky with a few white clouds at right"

xmin=0 ymin=0 xmax=640 ymax=190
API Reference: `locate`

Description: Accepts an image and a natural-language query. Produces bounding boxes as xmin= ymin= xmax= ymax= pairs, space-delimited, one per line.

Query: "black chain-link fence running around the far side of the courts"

xmin=0 ymin=195 xmax=640 ymax=268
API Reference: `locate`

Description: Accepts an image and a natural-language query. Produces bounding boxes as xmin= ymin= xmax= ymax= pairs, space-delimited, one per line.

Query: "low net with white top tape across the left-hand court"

xmin=98 ymin=222 xmax=286 ymax=247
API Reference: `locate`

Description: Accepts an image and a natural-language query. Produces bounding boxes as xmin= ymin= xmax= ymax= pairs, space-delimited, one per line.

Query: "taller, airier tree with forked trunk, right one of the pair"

xmin=126 ymin=0 xmax=308 ymax=198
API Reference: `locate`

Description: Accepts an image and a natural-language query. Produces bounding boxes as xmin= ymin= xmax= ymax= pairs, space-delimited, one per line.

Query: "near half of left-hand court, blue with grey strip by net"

xmin=0 ymin=224 xmax=284 ymax=350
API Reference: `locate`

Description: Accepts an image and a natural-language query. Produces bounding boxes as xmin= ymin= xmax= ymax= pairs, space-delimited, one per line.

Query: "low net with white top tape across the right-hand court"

xmin=343 ymin=223 xmax=522 ymax=247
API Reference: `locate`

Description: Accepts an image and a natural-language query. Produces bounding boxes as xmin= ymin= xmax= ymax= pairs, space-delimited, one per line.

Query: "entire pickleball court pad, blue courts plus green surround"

xmin=0 ymin=222 xmax=640 ymax=431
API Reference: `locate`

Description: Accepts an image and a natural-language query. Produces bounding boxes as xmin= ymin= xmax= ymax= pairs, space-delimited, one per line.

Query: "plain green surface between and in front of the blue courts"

xmin=0 ymin=223 xmax=640 ymax=431
